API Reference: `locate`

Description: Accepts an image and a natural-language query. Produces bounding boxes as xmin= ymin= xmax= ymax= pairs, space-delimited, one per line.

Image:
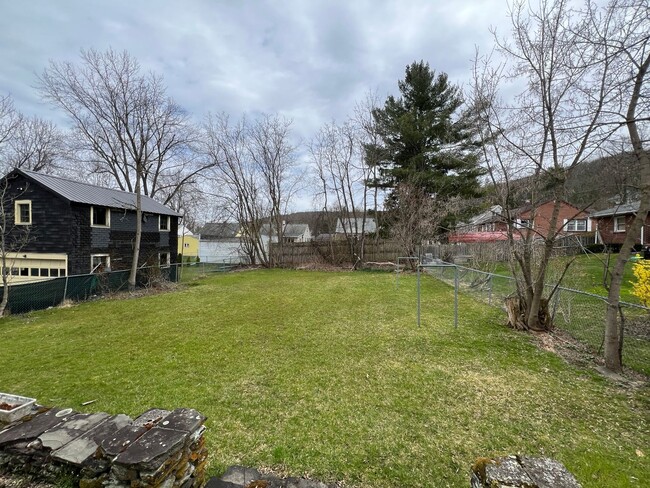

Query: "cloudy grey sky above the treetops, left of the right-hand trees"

xmin=0 ymin=0 xmax=507 ymax=138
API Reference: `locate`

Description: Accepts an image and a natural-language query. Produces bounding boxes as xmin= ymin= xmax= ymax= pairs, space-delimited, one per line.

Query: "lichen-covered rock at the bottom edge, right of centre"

xmin=471 ymin=456 xmax=581 ymax=488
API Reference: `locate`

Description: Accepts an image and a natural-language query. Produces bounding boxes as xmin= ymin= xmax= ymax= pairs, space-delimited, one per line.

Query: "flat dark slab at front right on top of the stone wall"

xmin=114 ymin=427 xmax=187 ymax=465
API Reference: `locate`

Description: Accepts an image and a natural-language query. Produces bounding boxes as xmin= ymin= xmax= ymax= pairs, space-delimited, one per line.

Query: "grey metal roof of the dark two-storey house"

xmin=14 ymin=168 xmax=180 ymax=217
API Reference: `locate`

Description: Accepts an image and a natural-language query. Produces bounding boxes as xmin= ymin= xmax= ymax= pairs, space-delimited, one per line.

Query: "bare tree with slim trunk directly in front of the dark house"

xmin=39 ymin=49 xmax=195 ymax=289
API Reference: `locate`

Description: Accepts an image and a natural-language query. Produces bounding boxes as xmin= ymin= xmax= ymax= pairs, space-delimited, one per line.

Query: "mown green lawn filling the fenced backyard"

xmin=0 ymin=270 xmax=650 ymax=488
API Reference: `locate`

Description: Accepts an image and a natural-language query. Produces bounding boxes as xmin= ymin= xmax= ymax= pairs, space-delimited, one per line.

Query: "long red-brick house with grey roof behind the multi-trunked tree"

xmin=449 ymin=200 xmax=592 ymax=242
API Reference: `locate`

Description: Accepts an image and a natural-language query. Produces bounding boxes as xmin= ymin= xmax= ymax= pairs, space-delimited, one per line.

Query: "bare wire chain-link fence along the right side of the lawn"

xmin=426 ymin=265 xmax=650 ymax=374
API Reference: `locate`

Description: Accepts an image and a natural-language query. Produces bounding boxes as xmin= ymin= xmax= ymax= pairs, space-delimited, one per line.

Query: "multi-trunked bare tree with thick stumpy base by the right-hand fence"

xmin=473 ymin=0 xmax=611 ymax=330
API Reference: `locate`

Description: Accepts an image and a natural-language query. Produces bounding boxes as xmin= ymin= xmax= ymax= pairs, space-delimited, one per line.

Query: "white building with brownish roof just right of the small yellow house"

xmin=199 ymin=222 xmax=246 ymax=263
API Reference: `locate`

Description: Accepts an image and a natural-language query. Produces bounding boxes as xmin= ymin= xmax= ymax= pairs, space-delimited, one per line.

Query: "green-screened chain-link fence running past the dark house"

xmin=0 ymin=261 xmax=238 ymax=314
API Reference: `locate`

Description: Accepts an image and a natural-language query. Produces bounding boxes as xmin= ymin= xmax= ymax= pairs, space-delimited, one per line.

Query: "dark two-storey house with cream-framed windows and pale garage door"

xmin=2 ymin=169 xmax=179 ymax=283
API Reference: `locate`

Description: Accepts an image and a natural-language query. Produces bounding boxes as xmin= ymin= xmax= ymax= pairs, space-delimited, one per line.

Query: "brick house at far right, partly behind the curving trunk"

xmin=591 ymin=202 xmax=650 ymax=246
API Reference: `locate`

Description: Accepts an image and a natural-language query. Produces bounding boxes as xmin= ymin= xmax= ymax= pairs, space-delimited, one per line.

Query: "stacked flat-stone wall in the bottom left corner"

xmin=0 ymin=407 xmax=207 ymax=488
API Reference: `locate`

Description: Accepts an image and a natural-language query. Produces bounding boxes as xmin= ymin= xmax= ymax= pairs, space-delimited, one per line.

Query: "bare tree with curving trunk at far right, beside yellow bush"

xmin=581 ymin=0 xmax=650 ymax=371
